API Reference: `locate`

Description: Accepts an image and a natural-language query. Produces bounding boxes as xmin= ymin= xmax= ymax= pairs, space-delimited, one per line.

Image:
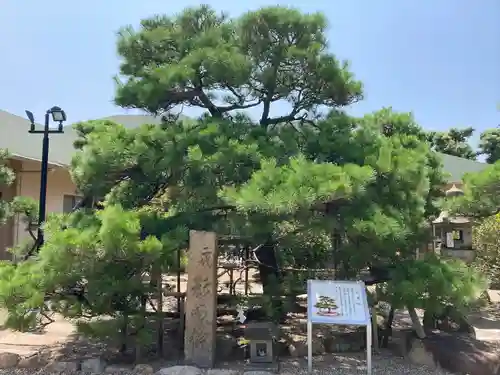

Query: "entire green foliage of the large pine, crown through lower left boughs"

xmin=0 ymin=6 xmax=480 ymax=350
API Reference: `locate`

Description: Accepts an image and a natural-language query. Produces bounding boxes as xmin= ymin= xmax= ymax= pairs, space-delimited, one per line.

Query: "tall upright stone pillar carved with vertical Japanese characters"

xmin=184 ymin=231 xmax=217 ymax=367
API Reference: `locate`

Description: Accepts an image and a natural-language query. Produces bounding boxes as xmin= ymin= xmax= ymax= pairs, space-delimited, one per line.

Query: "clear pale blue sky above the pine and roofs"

xmin=0 ymin=0 xmax=500 ymax=144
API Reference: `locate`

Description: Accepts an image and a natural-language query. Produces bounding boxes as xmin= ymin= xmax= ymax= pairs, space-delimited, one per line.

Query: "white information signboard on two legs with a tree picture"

xmin=307 ymin=280 xmax=372 ymax=375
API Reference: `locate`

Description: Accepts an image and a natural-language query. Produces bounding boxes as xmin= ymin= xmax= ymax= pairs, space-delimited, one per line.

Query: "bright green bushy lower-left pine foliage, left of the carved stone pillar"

xmin=0 ymin=206 xmax=162 ymax=328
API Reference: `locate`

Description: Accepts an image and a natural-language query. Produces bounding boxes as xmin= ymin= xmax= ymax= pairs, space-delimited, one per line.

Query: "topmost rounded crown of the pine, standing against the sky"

xmin=116 ymin=6 xmax=362 ymax=119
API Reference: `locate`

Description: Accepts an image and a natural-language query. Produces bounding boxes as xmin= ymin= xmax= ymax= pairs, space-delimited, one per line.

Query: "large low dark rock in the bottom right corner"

xmin=391 ymin=330 xmax=500 ymax=375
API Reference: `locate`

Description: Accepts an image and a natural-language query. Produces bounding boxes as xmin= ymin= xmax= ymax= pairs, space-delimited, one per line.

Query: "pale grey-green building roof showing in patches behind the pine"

xmin=0 ymin=110 xmax=488 ymax=183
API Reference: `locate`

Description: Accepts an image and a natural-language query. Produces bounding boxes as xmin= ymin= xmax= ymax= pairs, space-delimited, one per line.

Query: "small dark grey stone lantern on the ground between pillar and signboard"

xmin=245 ymin=322 xmax=276 ymax=363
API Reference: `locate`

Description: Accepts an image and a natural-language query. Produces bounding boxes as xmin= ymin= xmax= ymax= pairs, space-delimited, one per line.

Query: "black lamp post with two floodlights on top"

xmin=26 ymin=107 xmax=66 ymax=250
